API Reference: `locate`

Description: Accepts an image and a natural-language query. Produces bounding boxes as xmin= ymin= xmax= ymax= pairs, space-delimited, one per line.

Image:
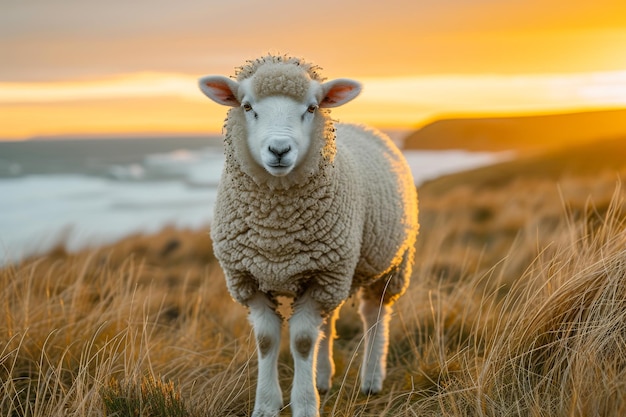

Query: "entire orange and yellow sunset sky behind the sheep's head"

xmin=0 ymin=0 xmax=626 ymax=140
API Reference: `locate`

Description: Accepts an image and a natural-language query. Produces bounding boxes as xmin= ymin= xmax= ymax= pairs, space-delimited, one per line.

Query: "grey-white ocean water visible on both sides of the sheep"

xmin=0 ymin=136 xmax=509 ymax=264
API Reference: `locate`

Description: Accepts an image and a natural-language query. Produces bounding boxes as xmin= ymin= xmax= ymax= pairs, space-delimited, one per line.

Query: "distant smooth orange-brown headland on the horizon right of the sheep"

xmin=404 ymin=110 xmax=626 ymax=151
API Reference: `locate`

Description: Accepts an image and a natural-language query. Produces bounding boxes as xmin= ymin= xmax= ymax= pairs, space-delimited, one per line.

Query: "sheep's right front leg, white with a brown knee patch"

xmin=289 ymin=294 xmax=323 ymax=417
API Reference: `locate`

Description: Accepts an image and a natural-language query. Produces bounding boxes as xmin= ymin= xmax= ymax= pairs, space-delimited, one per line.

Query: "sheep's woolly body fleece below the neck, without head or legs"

xmin=212 ymin=125 xmax=417 ymax=311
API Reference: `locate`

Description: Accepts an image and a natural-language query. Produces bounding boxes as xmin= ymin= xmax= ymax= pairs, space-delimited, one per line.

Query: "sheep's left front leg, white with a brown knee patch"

xmin=248 ymin=292 xmax=283 ymax=417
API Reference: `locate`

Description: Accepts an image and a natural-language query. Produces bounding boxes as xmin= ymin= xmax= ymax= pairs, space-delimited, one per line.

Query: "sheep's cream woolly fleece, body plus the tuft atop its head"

xmin=211 ymin=56 xmax=418 ymax=313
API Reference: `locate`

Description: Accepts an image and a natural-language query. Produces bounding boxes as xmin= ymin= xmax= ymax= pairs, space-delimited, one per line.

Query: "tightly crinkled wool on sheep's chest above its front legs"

xmin=212 ymin=156 xmax=360 ymax=311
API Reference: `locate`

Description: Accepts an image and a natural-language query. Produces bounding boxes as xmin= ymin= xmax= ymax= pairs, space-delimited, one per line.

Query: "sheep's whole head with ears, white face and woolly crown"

xmin=200 ymin=57 xmax=361 ymax=177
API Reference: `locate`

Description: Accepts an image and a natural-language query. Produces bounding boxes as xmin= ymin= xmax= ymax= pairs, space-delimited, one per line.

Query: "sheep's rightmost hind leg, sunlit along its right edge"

xmin=359 ymin=294 xmax=391 ymax=394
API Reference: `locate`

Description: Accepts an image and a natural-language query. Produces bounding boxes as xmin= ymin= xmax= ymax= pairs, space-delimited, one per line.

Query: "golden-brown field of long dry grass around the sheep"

xmin=0 ymin=139 xmax=626 ymax=416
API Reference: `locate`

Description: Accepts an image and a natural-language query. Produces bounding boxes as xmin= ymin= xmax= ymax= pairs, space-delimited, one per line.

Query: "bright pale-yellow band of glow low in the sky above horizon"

xmin=0 ymin=71 xmax=626 ymax=139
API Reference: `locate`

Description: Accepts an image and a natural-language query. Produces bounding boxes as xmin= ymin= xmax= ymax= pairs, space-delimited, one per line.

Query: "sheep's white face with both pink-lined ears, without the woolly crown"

xmin=200 ymin=70 xmax=361 ymax=177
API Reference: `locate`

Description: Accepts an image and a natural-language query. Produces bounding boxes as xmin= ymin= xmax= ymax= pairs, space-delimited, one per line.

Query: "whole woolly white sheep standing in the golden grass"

xmin=199 ymin=55 xmax=418 ymax=417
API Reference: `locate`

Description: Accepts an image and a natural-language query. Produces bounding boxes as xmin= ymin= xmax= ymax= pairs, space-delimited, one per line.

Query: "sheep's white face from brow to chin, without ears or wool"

xmin=241 ymin=91 xmax=318 ymax=177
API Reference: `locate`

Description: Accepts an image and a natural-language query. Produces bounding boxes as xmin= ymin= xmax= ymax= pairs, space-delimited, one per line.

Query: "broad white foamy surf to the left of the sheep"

xmin=0 ymin=176 xmax=216 ymax=264
